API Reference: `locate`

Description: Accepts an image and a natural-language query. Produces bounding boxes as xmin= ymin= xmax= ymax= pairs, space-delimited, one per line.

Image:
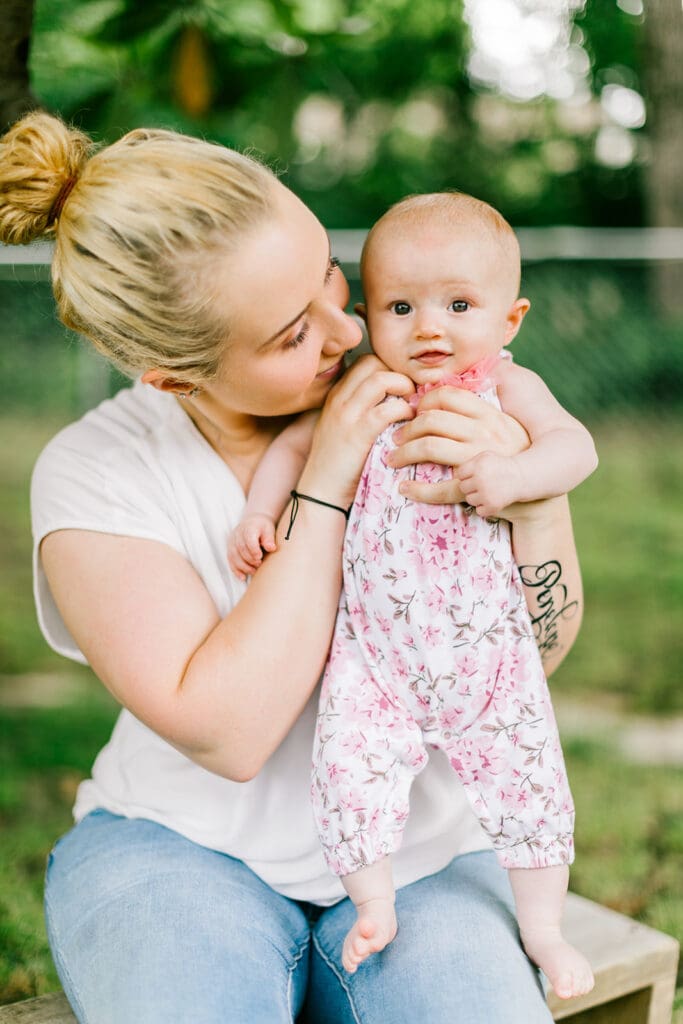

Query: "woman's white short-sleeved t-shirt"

xmin=32 ymin=382 xmax=489 ymax=904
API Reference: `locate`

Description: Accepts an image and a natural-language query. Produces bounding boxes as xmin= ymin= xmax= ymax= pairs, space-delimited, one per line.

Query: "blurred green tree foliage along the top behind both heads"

xmin=26 ymin=0 xmax=642 ymax=227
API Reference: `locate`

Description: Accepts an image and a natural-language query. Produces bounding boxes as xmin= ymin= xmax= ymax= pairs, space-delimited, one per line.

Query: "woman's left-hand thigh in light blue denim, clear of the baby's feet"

xmin=45 ymin=811 xmax=310 ymax=1024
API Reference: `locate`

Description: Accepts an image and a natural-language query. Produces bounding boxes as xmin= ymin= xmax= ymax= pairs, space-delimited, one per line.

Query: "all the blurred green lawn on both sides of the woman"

xmin=0 ymin=414 xmax=683 ymax=1007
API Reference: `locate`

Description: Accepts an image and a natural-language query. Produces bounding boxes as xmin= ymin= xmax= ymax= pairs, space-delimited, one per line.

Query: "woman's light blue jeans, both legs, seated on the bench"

xmin=45 ymin=811 xmax=551 ymax=1024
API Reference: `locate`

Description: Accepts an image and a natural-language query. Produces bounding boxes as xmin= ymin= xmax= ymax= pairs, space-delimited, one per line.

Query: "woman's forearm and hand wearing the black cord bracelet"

xmin=176 ymin=357 xmax=413 ymax=778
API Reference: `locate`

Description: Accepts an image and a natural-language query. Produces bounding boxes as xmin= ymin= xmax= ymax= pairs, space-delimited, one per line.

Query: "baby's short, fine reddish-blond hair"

xmin=360 ymin=191 xmax=521 ymax=297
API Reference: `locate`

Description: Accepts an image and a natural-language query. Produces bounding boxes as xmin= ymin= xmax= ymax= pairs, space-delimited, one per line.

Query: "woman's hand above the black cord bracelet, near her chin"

xmin=298 ymin=355 xmax=415 ymax=507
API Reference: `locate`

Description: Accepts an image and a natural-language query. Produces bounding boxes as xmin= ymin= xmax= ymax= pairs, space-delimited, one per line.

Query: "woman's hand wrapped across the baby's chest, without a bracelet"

xmin=389 ymin=387 xmax=529 ymax=505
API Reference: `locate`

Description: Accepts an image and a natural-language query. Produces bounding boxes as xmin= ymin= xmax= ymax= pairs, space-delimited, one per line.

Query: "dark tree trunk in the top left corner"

xmin=0 ymin=0 xmax=40 ymax=133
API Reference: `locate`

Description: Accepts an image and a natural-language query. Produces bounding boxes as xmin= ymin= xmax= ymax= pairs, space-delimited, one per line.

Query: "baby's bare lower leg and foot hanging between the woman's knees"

xmin=341 ymin=857 xmax=396 ymax=974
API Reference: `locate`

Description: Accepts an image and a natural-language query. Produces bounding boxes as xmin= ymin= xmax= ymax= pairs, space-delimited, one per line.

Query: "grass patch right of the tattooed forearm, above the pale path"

xmin=553 ymin=417 xmax=683 ymax=714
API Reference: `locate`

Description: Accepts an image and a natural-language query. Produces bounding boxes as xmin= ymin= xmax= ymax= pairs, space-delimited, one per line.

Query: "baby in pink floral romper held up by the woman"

xmin=228 ymin=193 xmax=597 ymax=998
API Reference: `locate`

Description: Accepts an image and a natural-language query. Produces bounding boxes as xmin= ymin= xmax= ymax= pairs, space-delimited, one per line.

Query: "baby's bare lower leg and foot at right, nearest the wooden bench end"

xmin=510 ymin=864 xmax=594 ymax=999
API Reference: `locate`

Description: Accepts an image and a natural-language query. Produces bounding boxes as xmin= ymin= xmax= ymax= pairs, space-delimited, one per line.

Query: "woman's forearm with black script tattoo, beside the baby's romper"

xmin=512 ymin=497 xmax=584 ymax=676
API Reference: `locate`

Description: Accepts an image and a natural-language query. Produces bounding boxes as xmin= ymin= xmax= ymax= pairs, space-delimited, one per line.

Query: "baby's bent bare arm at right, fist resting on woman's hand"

xmin=456 ymin=362 xmax=598 ymax=517
